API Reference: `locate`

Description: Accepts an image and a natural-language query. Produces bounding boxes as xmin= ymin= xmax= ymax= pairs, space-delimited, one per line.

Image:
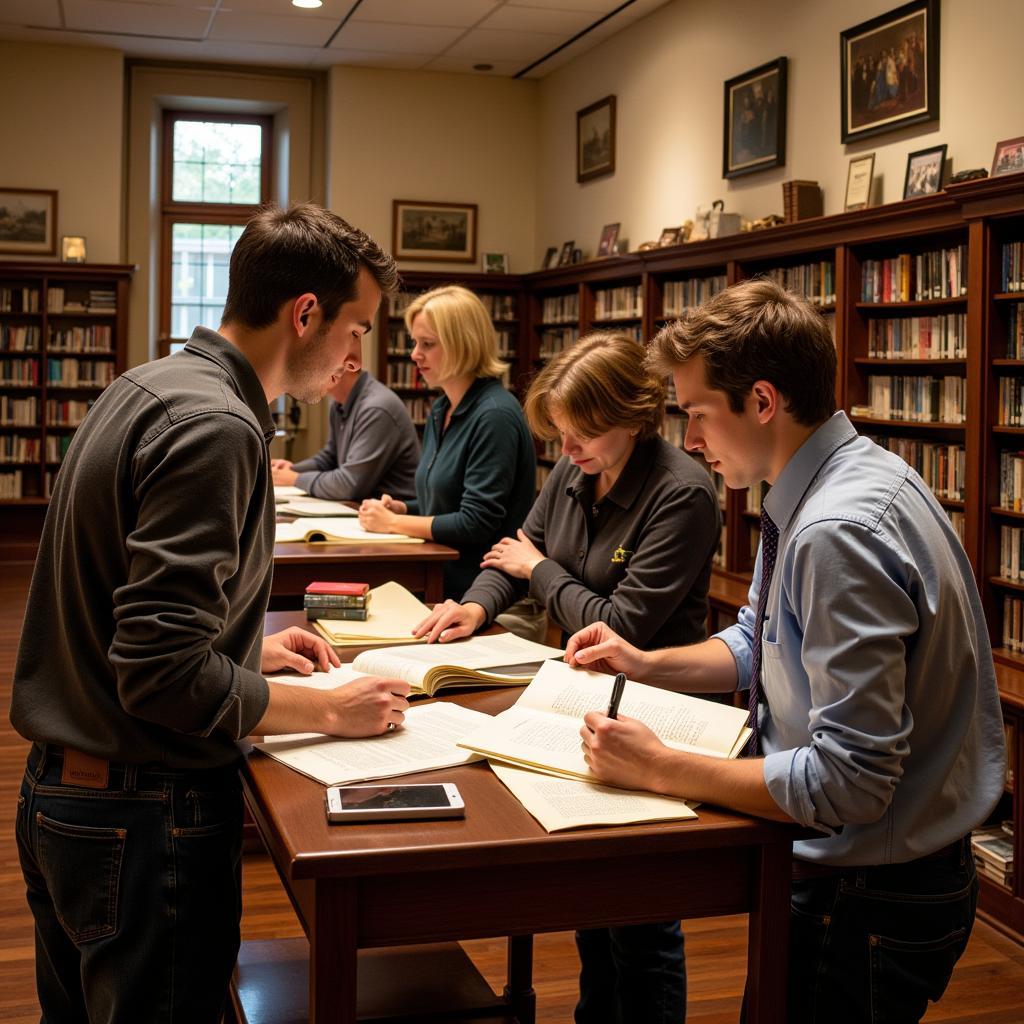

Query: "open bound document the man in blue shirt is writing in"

xmin=462 ymin=662 xmax=750 ymax=781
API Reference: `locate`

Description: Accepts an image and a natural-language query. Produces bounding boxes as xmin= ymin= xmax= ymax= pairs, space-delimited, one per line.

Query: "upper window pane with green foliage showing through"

xmin=171 ymin=121 xmax=263 ymax=204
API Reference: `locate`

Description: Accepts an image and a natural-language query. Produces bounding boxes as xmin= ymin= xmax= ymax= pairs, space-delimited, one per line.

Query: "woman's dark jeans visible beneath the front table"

xmin=573 ymin=921 xmax=686 ymax=1024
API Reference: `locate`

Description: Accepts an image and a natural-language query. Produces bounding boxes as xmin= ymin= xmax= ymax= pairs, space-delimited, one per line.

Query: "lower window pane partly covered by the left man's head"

xmin=171 ymin=223 xmax=245 ymax=338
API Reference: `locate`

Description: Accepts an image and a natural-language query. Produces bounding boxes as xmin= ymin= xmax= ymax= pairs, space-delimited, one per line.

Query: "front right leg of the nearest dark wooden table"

xmin=746 ymin=843 xmax=793 ymax=1024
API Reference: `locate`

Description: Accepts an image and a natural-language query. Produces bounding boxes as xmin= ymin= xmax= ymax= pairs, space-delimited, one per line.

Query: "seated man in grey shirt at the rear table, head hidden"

xmin=270 ymin=370 xmax=420 ymax=502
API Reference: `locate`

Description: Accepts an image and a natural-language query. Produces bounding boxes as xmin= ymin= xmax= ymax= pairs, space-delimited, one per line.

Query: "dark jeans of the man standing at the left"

xmin=15 ymin=744 xmax=242 ymax=1024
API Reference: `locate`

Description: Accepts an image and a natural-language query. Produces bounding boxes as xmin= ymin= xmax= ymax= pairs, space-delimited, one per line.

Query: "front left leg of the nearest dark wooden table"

xmin=309 ymin=880 xmax=358 ymax=1024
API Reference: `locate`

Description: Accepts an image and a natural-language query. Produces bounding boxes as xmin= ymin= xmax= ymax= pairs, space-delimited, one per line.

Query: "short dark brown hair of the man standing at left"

xmin=220 ymin=203 xmax=398 ymax=331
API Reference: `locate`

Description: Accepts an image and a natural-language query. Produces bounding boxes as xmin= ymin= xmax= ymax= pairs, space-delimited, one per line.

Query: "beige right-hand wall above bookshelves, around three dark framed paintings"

xmin=534 ymin=0 xmax=1024 ymax=260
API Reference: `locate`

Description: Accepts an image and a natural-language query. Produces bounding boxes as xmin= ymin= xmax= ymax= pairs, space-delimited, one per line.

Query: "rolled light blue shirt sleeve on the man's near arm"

xmin=764 ymin=520 xmax=919 ymax=831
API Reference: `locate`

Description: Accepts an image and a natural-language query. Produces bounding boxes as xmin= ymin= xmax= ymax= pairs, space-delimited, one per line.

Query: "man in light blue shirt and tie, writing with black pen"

xmin=567 ymin=281 xmax=1006 ymax=1024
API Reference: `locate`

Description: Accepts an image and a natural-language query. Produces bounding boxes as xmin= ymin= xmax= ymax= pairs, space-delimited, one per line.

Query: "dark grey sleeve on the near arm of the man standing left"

xmin=110 ymin=413 xmax=269 ymax=738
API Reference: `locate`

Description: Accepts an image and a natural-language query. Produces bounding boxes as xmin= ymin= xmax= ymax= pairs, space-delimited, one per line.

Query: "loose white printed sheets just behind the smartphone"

xmin=254 ymin=703 xmax=489 ymax=785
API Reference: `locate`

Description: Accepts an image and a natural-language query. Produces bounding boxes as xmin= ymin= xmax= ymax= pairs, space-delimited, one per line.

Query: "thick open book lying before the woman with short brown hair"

xmin=352 ymin=633 xmax=564 ymax=694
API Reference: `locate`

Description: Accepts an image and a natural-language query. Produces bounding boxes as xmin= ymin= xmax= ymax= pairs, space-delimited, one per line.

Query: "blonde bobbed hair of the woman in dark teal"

xmin=406 ymin=285 xmax=506 ymax=377
